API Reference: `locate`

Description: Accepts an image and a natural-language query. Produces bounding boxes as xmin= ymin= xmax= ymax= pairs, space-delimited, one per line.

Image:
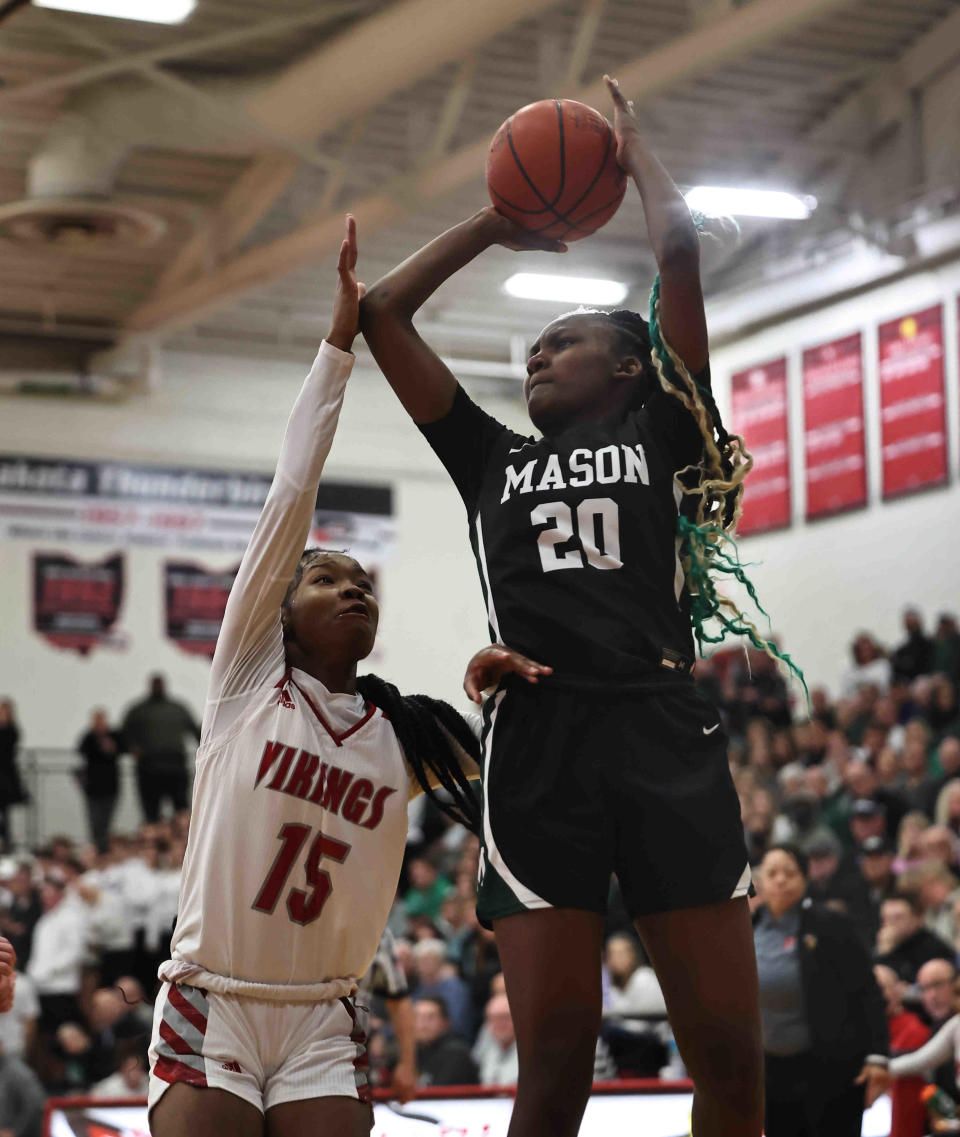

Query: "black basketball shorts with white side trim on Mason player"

xmin=477 ymin=680 xmax=751 ymax=927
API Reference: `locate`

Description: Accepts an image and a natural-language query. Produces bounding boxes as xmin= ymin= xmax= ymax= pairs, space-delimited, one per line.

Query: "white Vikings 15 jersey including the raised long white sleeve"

xmin=159 ymin=342 xmax=420 ymax=1001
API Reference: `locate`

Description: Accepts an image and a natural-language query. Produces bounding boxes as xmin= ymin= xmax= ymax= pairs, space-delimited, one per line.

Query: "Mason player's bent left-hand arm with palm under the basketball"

xmin=361 ymin=206 xmax=565 ymax=423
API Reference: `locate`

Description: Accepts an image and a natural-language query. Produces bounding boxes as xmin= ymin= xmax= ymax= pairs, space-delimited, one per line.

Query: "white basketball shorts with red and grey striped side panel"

xmin=148 ymin=984 xmax=370 ymax=1113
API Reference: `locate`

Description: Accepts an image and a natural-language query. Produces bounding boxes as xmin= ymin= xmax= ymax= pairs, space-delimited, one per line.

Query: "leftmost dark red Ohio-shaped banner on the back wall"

xmin=33 ymin=553 xmax=124 ymax=655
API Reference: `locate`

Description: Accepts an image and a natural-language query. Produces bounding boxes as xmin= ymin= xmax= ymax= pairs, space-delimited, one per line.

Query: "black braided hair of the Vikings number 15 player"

xmin=281 ymin=547 xmax=481 ymax=836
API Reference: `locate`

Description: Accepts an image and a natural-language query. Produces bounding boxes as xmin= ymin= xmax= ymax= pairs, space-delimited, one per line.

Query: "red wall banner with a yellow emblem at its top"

xmin=879 ymin=305 xmax=947 ymax=498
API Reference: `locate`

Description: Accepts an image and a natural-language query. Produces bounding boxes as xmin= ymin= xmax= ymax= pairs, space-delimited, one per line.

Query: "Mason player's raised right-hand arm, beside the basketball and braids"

xmin=604 ymin=76 xmax=707 ymax=374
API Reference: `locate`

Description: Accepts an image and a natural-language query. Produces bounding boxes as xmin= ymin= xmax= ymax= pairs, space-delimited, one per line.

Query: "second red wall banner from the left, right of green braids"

xmin=800 ymin=332 xmax=867 ymax=520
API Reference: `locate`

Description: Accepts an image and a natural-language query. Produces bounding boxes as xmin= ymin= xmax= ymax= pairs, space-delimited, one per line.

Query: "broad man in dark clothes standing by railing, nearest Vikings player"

xmin=121 ymin=675 xmax=200 ymax=821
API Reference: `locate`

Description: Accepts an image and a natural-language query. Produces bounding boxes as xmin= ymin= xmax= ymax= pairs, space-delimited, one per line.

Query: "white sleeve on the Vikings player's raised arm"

xmin=201 ymin=340 xmax=354 ymax=746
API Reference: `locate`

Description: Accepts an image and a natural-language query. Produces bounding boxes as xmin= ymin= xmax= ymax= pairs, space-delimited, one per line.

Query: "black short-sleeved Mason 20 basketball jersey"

xmin=420 ymin=370 xmax=709 ymax=686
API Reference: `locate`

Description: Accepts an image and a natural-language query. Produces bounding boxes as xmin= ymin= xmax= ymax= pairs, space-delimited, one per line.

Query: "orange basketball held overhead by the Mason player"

xmin=487 ymin=99 xmax=627 ymax=241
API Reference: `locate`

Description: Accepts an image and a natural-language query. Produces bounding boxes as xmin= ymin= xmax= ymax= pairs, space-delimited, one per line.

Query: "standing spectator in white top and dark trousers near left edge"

xmin=27 ymin=871 xmax=90 ymax=1032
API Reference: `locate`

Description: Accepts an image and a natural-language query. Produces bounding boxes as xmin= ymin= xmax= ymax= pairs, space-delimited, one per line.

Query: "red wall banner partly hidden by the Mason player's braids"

xmin=730 ymin=358 xmax=791 ymax=536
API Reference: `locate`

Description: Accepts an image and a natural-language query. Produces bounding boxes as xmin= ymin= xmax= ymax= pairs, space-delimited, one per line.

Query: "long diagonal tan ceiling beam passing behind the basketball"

xmin=126 ymin=0 xmax=853 ymax=333
